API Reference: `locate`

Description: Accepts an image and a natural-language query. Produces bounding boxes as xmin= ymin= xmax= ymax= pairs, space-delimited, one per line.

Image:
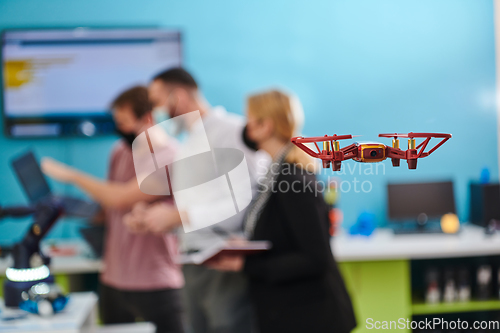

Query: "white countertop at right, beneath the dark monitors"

xmin=332 ymin=225 xmax=500 ymax=262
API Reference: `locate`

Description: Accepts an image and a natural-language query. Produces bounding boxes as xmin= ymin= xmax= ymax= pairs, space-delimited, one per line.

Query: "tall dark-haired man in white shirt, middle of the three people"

xmin=126 ymin=68 xmax=268 ymax=333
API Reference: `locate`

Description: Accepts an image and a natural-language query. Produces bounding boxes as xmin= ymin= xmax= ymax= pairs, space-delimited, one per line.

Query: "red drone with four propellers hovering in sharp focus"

xmin=292 ymin=132 xmax=451 ymax=171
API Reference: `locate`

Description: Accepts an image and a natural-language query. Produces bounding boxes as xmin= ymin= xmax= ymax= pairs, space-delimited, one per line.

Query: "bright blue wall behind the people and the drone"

xmin=0 ymin=0 xmax=498 ymax=242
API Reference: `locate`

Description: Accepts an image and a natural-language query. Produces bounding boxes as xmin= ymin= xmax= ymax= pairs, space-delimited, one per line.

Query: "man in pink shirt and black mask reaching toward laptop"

xmin=42 ymin=86 xmax=184 ymax=333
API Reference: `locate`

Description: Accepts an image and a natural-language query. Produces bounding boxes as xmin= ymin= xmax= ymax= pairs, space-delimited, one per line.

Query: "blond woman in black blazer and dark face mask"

xmin=206 ymin=90 xmax=356 ymax=333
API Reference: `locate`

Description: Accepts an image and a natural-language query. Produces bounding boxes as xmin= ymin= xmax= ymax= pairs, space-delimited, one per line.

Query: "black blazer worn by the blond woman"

xmin=244 ymin=163 xmax=356 ymax=333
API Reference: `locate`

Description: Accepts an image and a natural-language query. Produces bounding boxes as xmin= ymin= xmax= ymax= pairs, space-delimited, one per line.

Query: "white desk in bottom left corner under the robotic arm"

xmin=0 ymin=293 xmax=97 ymax=333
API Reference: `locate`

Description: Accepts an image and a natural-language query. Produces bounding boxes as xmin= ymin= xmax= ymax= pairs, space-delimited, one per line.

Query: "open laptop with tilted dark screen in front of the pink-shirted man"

xmin=12 ymin=151 xmax=99 ymax=218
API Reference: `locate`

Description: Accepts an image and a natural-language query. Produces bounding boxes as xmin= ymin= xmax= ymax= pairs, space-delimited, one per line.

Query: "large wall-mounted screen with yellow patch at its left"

xmin=2 ymin=28 xmax=181 ymax=137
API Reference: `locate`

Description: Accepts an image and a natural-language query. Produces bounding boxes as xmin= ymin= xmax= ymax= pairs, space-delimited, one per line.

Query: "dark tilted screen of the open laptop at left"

xmin=12 ymin=152 xmax=50 ymax=203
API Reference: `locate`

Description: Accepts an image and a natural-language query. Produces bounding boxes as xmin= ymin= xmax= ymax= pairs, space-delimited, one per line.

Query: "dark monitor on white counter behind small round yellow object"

xmin=387 ymin=181 xmax=456 ymax=221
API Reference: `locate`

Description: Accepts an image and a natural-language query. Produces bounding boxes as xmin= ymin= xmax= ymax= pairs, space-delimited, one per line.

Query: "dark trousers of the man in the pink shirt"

xmin=99 ymin=284 xmax=184 ymax=333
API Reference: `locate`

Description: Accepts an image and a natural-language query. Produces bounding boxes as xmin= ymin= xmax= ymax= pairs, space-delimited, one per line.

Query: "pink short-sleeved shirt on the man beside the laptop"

xmin=101 ymin=140 xmax=184 ymax=290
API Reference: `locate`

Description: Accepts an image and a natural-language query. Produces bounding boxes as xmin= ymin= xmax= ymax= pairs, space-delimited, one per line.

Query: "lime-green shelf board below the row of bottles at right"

xmin=412 ymin=300 xmax=500 ymax=316
